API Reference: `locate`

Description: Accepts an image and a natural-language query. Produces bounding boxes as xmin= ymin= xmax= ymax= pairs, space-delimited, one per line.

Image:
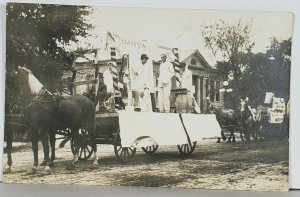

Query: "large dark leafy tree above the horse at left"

xmin=6 ymin=3 xmax=92 ymax=90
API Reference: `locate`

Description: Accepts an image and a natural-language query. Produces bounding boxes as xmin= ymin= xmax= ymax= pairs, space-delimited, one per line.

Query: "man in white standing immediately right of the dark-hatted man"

xmin=158 ymin=54 xmax=175 ymax=113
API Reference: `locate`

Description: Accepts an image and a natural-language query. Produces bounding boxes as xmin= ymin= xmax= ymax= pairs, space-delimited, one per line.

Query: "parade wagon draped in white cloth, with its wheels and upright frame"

xmin=57 ymin=50 xmax=221 ymax=162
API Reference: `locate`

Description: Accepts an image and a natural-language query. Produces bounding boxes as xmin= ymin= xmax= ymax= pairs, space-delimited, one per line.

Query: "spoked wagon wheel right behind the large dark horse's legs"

xmin=70 ymin=129 xmax=94 ymax=161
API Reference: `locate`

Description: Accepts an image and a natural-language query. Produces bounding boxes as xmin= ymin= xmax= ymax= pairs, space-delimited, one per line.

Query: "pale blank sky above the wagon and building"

xmin=77 ymin=7 xmax=293 ymax=65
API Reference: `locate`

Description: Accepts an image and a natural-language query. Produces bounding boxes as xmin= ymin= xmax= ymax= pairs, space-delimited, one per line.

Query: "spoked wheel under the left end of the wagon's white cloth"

xmin=114 ymin=133 xmax=136 ymax=163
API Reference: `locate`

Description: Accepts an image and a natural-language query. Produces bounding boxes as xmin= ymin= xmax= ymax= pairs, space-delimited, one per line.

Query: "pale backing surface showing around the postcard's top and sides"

xmin=0 ymin=0 xmax=300 ymax=189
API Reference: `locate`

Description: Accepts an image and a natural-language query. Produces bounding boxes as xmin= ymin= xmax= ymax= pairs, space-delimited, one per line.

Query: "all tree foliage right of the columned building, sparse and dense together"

xmin=202 ymin=20 xmax=292 ymax=108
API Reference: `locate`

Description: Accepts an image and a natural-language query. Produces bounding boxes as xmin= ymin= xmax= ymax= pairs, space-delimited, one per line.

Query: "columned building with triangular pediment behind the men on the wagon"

xmin=63 ymin=49 xmax=224 ymax=113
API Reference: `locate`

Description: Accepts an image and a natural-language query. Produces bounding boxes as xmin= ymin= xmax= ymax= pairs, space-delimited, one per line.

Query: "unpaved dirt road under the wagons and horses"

xmin=3 ymin=139 xmax=289 ymax=191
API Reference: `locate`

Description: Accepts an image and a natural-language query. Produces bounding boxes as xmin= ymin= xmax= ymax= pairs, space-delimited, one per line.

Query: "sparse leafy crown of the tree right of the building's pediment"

xmin=202 ymin=20 xmax=254 ymax=75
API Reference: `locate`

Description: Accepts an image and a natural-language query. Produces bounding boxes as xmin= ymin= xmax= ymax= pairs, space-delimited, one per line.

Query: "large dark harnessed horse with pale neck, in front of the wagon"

xmin=8 ymin=67 xmax=98 ymax=173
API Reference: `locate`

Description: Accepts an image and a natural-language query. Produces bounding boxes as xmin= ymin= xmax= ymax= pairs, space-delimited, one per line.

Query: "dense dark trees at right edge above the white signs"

xmin=239 ymin=38 xmax=291 ymax=103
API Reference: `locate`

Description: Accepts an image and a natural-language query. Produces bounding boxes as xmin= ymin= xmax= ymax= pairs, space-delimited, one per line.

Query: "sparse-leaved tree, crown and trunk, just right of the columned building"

xmin=202 ymin=20 xmax=254 ymax=108
